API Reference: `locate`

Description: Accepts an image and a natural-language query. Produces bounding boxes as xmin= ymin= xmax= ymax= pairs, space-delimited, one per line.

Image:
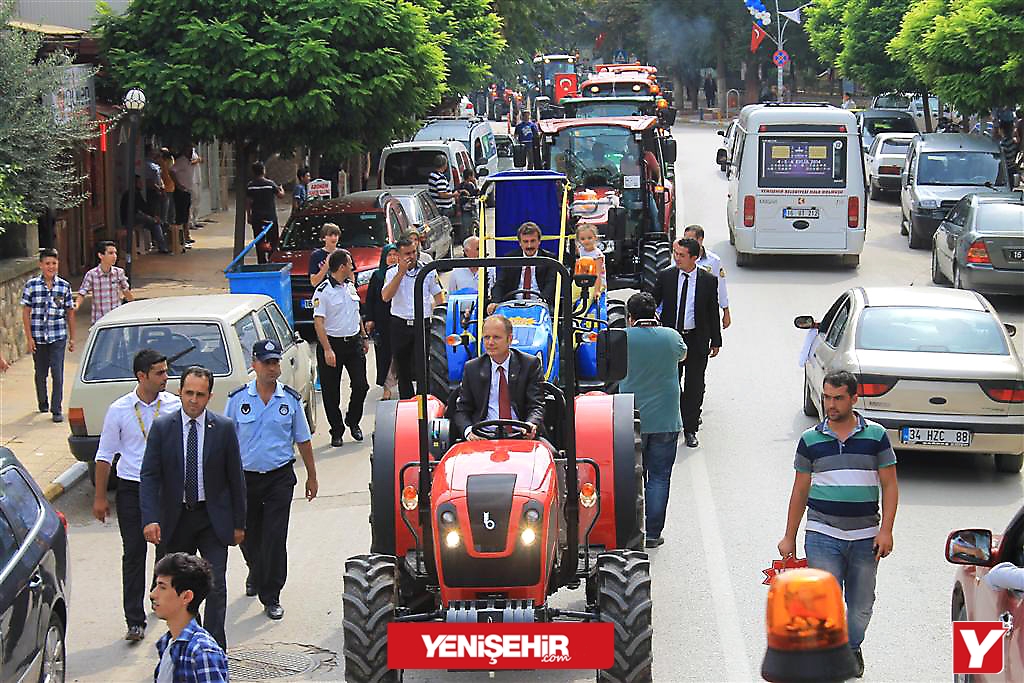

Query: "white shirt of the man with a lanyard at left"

xmin=96 ymin=389 xmax=181 ymax=481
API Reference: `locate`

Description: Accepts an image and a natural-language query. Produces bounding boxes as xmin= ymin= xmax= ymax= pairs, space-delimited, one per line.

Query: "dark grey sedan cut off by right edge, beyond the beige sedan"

xmin=932 ymin=191 xmax=1024 ymax=294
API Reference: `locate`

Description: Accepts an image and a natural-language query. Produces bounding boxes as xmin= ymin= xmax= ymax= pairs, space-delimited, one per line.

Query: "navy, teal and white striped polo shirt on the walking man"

xmin=794 ymin=413 xmax=896 ymax=541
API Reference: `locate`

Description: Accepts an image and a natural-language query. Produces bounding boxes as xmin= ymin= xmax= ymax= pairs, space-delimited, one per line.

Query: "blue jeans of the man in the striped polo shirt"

xmin=804 ymin=531 xmax=879 ymax=650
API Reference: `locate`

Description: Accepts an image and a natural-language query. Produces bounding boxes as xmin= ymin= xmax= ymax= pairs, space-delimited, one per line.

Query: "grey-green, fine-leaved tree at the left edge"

xmin=0 ymin=0 xmax=96 ymax=222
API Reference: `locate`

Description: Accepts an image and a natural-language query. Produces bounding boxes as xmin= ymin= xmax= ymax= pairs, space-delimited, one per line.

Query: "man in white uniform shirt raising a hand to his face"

xmin=381 ymin=238 xmax=444 ymax=398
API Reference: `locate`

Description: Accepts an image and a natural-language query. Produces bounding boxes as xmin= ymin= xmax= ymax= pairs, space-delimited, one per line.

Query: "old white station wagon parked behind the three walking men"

xmin=68 ymin=294 xmax=316 ymax=475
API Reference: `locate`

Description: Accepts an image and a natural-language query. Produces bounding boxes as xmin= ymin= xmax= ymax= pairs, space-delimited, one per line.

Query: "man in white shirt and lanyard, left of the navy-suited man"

xmin=92 ymin=348 xmax=181 ymax=642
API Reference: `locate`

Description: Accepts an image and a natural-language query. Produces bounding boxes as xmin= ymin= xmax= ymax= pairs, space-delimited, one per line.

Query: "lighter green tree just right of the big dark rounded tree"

xmin=416 ymin=0 xmax=506 ymax=95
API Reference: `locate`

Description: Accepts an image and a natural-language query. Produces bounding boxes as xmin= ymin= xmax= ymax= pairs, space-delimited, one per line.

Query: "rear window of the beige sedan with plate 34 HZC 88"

xmin=857 ymin=306 xmax=1010 ymax=355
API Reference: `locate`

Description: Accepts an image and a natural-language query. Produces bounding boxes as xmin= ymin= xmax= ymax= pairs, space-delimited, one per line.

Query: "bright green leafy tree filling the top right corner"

xmin=894 ymin=0 xmax=1024 ymax=112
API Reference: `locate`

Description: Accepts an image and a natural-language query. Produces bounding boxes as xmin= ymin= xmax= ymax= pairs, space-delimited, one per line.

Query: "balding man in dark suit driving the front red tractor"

xmin=455 ymin=315 xmax=544 ymax=440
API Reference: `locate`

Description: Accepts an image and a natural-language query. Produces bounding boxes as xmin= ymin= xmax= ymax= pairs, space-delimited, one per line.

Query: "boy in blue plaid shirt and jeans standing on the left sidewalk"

xmin=22 ymin=249 xmax=75 ymax=422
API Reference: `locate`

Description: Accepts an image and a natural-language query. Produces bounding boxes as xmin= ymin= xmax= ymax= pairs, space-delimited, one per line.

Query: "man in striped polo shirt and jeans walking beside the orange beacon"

xmin=778 ymin=371 xmax=899 ymax=678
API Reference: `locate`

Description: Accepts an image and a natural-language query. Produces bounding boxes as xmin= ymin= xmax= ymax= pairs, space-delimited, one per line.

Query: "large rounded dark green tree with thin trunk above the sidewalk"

xmin=97 ymin=0 xmax=445 ymax=251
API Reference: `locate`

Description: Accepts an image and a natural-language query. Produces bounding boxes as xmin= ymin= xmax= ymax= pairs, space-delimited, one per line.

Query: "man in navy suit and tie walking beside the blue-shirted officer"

xmin=139 ymin=366 xmax=246 ymax=649
